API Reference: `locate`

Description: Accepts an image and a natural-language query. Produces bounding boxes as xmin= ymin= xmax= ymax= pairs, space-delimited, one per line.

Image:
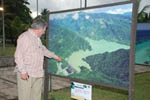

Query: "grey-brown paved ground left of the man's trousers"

xmin=0 ymin=67 xmax=17 ymax=100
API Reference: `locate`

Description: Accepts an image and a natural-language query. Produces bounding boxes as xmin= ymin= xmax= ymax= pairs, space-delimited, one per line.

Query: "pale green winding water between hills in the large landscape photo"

xmin=67 ymin=38 xmax=130 ymax=72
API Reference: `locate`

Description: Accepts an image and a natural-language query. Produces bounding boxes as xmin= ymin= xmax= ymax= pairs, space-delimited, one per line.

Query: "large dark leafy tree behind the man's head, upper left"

xmin=0 ymin=0 xmax=32 ymax=44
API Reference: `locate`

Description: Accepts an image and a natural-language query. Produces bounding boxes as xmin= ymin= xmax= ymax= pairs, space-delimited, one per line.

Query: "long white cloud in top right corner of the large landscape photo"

xmin=106 ymin=8 xmax=132 ymax=14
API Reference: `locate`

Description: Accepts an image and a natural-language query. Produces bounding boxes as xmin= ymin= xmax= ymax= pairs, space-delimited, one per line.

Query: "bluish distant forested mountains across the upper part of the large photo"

xmin=51 ymin=12 xmax=131 ymax=45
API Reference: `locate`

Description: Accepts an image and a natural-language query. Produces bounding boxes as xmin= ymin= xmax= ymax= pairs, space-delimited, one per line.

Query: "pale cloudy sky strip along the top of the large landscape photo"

xmin=50 ymin=4 xmax=132 ymax=20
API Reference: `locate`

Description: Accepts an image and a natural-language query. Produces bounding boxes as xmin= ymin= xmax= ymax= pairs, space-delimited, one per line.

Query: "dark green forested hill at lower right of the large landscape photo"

xmin=85 ymin=49 xmax=129 ymax=87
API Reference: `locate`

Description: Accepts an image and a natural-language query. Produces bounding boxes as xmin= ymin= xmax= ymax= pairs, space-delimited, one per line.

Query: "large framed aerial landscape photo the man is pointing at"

xmin=48 ymin=4 xmax=132 ymax=88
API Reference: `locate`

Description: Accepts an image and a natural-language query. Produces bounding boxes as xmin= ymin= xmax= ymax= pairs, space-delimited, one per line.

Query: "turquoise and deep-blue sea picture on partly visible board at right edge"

xmin=135 ymin=30 xmax=150 ymax=65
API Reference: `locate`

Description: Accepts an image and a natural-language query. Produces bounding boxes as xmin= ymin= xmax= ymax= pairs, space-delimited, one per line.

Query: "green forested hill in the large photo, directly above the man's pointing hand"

xmin=49 ymin=23 xmax=91 ymax=58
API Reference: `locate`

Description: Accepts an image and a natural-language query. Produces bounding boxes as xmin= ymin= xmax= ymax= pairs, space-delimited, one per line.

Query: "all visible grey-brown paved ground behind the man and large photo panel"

xmin=0 ymin=65 xmax=150 ymax=100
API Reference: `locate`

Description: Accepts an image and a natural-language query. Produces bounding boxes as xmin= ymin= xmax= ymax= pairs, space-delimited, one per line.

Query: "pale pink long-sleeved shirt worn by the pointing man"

xmin=15 ymin=29 xmax=57 ymax=77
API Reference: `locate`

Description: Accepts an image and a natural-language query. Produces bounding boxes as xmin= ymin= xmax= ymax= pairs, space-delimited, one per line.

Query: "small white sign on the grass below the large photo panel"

xmin=71 ymin=82 xmax=92 ymax=100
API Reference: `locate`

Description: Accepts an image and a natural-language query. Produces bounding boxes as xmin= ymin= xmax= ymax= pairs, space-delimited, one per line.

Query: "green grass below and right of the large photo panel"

xmin=42 ymin=72 xmax=150 ymax=100
